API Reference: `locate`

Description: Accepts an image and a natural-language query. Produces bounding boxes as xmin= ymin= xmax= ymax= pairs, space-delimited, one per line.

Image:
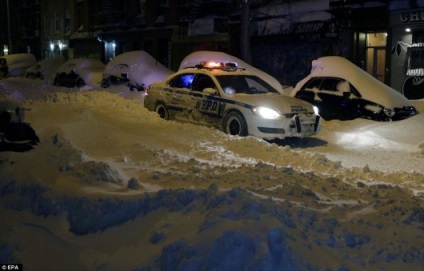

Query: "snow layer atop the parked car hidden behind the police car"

xmin=178 ymin=51 xmax=283 ymax=93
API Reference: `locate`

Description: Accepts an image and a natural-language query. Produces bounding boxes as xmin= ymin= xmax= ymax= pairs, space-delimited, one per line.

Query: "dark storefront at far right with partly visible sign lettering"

xmin=390 ymin=8 xmax=424 ymax=99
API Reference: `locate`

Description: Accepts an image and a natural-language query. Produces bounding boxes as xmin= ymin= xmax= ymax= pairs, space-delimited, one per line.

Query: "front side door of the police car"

xmin=190 ymin=73 xmax=220 ymax=125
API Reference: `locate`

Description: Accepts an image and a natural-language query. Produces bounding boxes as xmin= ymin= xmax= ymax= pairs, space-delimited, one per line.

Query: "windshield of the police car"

xmin=216 ymin=75 xmax=278 ymax=95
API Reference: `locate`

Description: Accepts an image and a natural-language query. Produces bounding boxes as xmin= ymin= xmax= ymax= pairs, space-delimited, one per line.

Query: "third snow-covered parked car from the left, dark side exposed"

xmin=53 ymin=58 xmax=105 ymax=88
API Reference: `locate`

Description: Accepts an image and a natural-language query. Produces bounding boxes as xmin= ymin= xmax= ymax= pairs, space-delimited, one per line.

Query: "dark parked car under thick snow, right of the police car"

xmin=291 ymin=56 xmax=418 ymax=121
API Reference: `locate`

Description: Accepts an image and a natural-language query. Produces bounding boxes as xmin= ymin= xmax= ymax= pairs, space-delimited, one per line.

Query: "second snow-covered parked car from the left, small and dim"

xmin=25 ymin=57 xmax=65 ymax=80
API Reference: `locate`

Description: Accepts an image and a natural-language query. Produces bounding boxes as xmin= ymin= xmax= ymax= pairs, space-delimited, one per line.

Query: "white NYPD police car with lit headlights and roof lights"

xmin=144 ymin=62 xmax=320 ymax=140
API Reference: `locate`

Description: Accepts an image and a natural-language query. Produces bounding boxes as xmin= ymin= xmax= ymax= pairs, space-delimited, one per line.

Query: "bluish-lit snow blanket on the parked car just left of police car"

xmin=104 ymin=50 xmax=174 ymax=86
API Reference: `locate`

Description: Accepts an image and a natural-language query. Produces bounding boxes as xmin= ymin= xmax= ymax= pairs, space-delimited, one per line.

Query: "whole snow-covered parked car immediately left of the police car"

xmin=101 ymin=51 xmax=173 ymax=91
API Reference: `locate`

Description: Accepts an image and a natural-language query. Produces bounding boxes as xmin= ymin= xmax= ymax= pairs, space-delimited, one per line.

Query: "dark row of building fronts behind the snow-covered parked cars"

xmin=0 ymin=0 xmax=424 ymax=93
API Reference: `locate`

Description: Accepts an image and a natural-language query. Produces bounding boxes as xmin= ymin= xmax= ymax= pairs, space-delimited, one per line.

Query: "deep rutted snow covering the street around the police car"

xmin=0 ymin=78 xmax=424 ymax=270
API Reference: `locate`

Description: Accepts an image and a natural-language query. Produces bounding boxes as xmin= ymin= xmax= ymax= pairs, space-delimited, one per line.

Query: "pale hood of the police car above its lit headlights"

xmin=225 ymin=93 xmax=314 ymax=114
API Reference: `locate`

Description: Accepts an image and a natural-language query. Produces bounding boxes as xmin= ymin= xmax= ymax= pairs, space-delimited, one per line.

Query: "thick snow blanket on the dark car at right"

xmin=295 ymin=56 xmax=412 ymax=107
